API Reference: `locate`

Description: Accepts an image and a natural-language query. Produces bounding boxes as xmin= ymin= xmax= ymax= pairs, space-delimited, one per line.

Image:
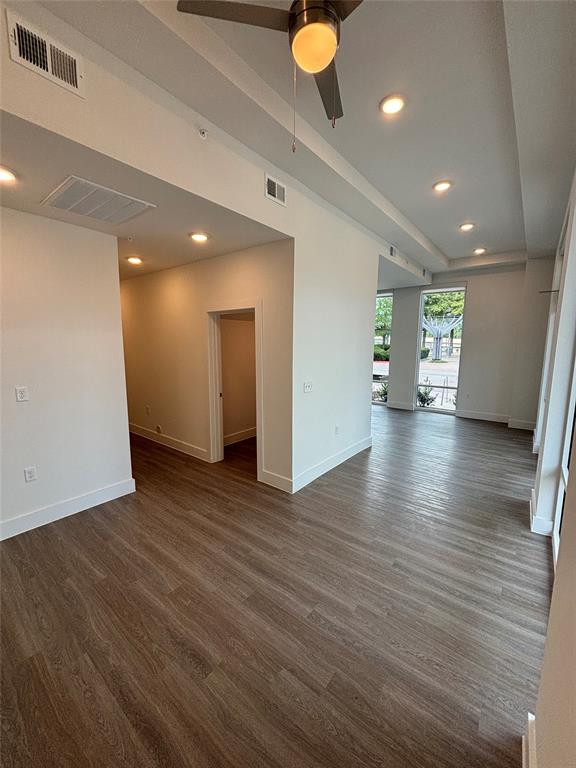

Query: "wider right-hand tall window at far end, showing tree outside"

xmin=416 ymin=288 xmax=466 ymax=413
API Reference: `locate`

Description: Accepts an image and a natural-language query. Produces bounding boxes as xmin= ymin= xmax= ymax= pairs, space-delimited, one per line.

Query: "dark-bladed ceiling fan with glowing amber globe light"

xmin=177 ymin=0 xmax=362 ymax=124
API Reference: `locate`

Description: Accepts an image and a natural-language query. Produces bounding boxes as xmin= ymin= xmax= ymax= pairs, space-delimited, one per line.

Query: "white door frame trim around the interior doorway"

xmin=205 ymin=299 xmax=264 ymax=480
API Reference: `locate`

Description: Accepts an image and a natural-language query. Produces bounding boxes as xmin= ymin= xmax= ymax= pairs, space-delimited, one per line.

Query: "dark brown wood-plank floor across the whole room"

xmin=2 ymin=407 xmax=551 ymax=768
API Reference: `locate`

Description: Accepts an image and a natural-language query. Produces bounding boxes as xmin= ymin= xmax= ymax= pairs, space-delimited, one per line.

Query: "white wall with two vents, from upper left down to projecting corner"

xmin=0 ymin=4 xmax=388 ymax=486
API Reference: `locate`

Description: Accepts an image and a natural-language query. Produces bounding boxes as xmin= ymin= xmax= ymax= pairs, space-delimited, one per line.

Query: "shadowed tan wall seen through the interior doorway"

xmin=220 ymin=312 xmax=256 ymax=445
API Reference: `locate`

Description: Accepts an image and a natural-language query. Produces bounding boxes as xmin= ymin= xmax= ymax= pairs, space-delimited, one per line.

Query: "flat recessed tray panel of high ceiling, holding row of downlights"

xmin=207 ymin=0 xmax=525 ymax=258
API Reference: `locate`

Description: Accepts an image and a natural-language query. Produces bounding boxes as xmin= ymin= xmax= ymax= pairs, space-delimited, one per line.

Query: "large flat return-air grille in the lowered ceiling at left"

xmin=42 ymin=176 xmax=156 ymax=224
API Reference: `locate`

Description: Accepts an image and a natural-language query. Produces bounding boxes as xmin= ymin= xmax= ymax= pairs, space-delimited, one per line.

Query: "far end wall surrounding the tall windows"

xmin=388 ymin=259 xmax=553 ymax=429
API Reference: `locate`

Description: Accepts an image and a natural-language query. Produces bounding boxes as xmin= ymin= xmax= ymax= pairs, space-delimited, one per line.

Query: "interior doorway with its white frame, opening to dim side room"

xmin=208 ymin=301 xmax=262 ymax=479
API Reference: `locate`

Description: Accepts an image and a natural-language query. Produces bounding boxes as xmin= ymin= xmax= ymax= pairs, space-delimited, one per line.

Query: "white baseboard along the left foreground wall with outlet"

xmin=0 ymin=478 xmax=136 ymax=539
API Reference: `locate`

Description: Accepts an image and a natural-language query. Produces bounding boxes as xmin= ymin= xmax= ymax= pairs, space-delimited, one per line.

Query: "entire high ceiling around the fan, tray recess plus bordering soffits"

xmin=20 ymin=0 xmax=576 ymax=271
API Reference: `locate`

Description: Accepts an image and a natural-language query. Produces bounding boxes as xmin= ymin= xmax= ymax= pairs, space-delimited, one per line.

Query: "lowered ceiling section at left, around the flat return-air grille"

xmin=0 ymin=112 xmax=285 ymax=278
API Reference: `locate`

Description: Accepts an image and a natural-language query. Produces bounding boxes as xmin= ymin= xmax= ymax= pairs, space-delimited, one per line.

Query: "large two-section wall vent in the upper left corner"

xmin=6 ymin=10 xmax=84 ymax=96
